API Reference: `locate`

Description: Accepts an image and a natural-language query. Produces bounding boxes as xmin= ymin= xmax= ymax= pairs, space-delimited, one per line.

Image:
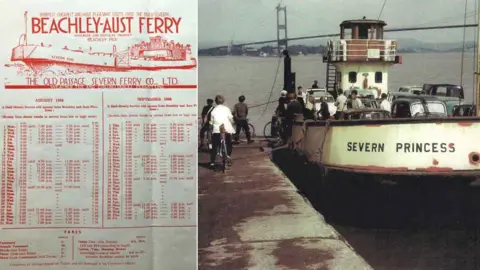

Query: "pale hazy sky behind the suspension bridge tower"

xmin=198 ymin=0 xmax=477 ymax=48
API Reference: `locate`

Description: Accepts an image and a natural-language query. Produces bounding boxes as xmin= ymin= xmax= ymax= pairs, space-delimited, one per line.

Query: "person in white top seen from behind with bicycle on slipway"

xmin=210 ymin=95 xmax=235 ymax=168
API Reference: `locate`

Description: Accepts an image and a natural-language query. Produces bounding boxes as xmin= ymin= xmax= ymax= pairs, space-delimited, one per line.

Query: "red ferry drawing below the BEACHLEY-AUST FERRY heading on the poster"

xmin=10 ymin=30 xmax=197 ymax=73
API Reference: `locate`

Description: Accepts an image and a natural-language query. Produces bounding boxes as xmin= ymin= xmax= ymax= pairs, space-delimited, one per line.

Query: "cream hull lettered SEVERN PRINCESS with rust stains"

xmin=293 ymin=118 xmax=480 ymax=177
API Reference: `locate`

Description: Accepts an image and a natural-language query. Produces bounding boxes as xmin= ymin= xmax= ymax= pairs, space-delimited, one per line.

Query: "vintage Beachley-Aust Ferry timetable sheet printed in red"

xmin=0 ymin=0 xmax=197 ymax=270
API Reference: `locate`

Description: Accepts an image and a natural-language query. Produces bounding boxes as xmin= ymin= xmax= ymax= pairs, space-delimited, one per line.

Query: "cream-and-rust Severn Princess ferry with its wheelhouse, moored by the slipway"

xmin=285 ymin=19 xmax=480 ymax=185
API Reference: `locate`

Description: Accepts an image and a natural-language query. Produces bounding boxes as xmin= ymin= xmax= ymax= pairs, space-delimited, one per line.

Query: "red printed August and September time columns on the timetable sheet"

xmin=0 ymin=90 xmax=197 ymax=227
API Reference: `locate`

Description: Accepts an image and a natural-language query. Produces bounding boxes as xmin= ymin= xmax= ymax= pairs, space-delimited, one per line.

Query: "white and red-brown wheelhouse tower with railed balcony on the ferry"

xmin=323 ymin=17 xmax=402 ymax=98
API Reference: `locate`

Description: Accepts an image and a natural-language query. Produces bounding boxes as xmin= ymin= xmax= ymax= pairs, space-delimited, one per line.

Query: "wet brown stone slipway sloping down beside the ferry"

xmin=198 ymin=143 xmax=372 ymax=270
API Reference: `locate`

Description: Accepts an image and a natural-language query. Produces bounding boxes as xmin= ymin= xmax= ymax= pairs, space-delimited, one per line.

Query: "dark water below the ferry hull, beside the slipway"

xmin=272 ymin=149 xmax=480 ymax=270
